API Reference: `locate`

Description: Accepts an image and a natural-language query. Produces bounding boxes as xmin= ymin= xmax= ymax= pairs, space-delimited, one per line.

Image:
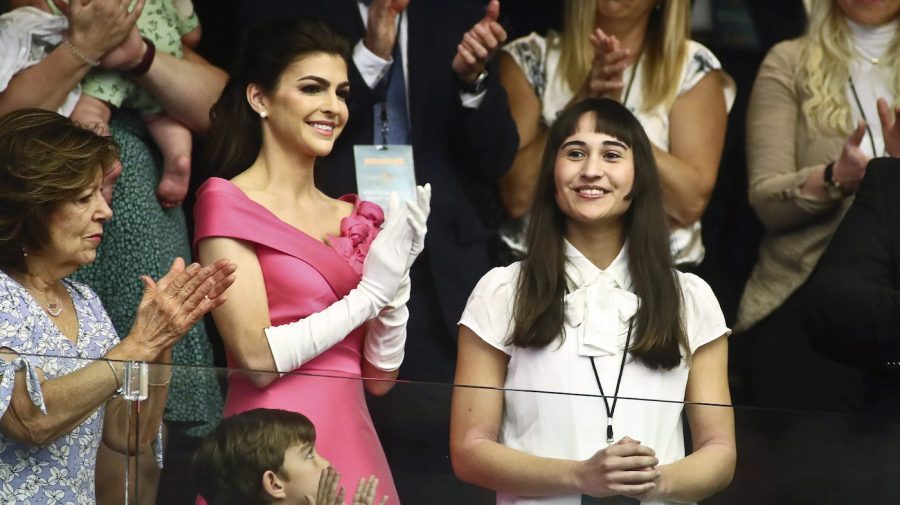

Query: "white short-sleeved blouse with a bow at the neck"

xmin=459 ymin=242 xmax=731 ymax=505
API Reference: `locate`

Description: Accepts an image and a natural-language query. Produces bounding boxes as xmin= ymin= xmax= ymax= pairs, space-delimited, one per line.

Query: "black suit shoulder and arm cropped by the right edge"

xmin=806 ymin=159 xmax=900 ymax=368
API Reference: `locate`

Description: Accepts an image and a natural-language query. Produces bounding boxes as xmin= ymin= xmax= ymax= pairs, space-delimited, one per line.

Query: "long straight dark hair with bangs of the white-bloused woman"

xmin=509 ymin=99 xmax=690 ymax=369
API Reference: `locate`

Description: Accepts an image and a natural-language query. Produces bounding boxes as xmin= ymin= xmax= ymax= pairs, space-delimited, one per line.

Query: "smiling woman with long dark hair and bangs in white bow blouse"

xmin=450 ymin=99 xmax=735 ymax=505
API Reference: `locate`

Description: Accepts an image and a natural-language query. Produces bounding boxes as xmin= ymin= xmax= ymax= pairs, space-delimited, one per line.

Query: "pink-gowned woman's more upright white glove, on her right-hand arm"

xmin=363 ymin=184 xmax=431 ymax=372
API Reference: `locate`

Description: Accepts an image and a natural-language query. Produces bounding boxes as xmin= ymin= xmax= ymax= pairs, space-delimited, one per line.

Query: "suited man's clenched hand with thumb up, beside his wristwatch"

xmin=451 ymin=0 xmax=506 ymax=83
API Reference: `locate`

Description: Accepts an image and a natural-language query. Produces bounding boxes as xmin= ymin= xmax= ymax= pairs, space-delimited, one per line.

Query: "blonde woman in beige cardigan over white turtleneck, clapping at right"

xmin=736 ymin=0 xmax=900 ymax=409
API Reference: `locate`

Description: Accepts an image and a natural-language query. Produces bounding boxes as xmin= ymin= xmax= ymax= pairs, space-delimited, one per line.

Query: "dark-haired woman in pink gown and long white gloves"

xmin=194 ymin=19 xmax=430 ymax=504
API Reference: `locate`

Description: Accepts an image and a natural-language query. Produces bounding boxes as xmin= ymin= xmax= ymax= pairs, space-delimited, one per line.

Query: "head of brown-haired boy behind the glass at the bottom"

xmin=193 ymin=409 xmax=329 ymax=505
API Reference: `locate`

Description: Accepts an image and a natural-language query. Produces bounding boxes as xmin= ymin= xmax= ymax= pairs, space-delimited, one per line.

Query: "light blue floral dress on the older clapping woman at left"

xmin=0 ymin=271 xmax=119 ymax=505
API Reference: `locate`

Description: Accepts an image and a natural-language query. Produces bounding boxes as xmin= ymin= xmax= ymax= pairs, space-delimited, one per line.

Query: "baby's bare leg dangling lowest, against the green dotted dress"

xmin=144 ymin=114 xmax=193 ymax=208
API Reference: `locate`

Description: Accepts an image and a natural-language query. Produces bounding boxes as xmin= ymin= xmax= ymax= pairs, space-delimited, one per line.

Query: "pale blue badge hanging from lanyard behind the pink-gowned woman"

xmin=353 ymin=145 xmax=416 ymax=211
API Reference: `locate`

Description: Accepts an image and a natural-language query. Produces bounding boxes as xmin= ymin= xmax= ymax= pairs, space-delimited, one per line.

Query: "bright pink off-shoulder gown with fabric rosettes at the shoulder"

xmin=194 ymin=178 xmax=399 ymax=505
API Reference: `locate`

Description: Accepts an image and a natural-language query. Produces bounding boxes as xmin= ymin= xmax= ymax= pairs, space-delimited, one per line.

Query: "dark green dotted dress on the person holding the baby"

xmin=73 ymin=111 xmax=222 ymax=436
